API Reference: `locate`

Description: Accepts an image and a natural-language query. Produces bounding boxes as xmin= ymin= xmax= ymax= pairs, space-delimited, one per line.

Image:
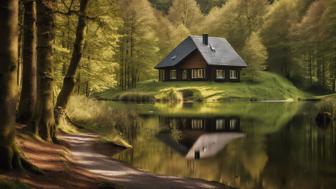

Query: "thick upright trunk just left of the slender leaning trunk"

xmin=31 ymin=0 xmax=56 ymax=142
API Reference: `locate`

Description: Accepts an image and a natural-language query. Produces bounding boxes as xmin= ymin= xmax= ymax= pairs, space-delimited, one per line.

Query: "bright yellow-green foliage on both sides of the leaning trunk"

xmin=54 ymin=0 xmax=122 ymax=95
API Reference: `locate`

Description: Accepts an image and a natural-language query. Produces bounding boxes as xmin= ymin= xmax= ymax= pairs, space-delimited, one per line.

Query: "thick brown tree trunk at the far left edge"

xmin=0 ymin=0 xmax=21 ymax=170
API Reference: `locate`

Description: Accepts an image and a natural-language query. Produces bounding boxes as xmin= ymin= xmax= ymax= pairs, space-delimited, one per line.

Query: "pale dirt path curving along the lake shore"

xmin=59 ymin=134 xmax=225 ymax=189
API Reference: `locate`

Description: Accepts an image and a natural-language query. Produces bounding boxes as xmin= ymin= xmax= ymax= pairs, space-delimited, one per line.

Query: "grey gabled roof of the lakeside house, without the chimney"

xmin=155 ymin=36 xmax=247 ymax=69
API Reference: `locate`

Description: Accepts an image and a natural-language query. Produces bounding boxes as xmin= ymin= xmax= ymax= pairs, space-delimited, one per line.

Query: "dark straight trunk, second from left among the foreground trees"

xmin=17 ymin=0 xmax=36 ymax=123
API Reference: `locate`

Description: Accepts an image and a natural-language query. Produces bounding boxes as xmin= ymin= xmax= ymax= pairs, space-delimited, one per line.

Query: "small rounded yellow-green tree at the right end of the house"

xmin=241 ymin=33 xmax=267 ymax=81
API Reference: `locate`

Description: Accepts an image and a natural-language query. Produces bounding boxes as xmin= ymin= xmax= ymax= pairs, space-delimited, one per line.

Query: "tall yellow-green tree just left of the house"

xmin=115 ymin=0 xmax=159 ymax=89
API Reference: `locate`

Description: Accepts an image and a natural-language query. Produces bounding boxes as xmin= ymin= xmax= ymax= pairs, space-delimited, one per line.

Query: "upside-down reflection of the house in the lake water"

xmin=158 ymin=117 xmax=245 ymax=159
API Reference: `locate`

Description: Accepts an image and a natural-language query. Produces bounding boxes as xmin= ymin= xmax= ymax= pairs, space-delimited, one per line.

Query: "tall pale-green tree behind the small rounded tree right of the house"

xmin=261 ymin=0 xmax=300 ymax=77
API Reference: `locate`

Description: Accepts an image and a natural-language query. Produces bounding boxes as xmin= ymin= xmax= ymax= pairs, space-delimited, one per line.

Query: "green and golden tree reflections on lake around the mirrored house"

xmin=112 ymin=104 xmax=336 ymax=188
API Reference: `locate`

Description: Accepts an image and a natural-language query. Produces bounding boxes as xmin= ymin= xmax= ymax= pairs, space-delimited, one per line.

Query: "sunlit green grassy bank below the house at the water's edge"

xmin=98 ymin=72 xmax=309 ymax=102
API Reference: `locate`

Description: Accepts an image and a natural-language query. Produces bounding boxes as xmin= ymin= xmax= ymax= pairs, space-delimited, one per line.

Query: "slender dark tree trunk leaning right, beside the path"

xmin=55 ymin=0 xmax=89 ymax=124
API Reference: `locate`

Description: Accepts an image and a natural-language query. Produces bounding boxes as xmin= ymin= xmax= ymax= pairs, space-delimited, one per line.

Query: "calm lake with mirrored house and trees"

xmin=111 ymin=102 xmax=336 ymax=189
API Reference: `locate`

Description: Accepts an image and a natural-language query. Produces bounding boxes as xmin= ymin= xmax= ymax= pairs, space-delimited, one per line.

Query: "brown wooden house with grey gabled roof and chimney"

xmin=155 ymin=34 xmax=247 ymax=81
